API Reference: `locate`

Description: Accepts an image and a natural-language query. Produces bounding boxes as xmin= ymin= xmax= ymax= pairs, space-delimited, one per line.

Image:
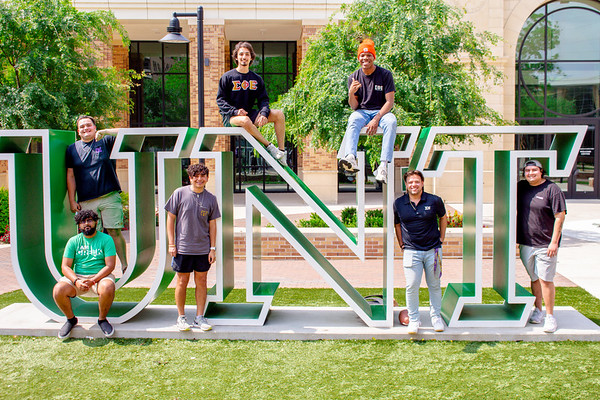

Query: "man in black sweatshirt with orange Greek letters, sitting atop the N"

xmin=217 ymin=42 xmax=287 ymax=165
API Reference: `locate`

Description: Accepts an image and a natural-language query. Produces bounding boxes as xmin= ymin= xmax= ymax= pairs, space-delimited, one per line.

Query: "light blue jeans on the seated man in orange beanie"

xmin=338 ymin=109 xmax=398 ymax=162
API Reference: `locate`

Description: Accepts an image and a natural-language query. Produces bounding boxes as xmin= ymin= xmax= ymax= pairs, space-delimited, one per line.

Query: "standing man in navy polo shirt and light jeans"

xmin=394 ymin=171 xmax=448 ymax=334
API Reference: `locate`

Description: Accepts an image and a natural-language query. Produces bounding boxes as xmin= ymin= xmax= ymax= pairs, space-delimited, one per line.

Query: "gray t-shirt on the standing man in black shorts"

xmin=165 ymin=186 xmax=221 ymax=255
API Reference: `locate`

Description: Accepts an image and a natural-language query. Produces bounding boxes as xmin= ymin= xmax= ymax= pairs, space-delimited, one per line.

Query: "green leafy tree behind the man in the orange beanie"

xmin=273 ymin=0 xmax=504 ymax=162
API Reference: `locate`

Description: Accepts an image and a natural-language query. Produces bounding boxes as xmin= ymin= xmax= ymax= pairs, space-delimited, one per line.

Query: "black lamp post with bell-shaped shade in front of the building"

xmin=159 ymin=6 xmax=204 ymax=127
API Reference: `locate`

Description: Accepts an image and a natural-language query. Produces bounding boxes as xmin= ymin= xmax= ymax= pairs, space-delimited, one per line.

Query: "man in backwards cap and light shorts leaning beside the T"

xmin=517 ymin=160 xmax=567 ymax=333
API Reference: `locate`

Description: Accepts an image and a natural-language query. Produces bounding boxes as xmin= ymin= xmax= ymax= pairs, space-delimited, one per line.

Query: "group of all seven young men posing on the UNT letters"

xmin=54 ymin=39 xmax=566 ymax=339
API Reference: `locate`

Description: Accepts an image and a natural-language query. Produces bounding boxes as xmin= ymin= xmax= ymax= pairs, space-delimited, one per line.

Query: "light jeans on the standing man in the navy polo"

xmin=402 ymin=247 xmax=442 ymax=321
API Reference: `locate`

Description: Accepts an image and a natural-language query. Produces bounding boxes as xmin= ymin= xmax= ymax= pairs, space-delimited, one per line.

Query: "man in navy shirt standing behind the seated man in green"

xmin=65 ymin=115 xmax=127 ymax=272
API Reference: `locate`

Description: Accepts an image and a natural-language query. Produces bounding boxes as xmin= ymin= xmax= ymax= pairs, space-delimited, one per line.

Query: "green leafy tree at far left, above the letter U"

xmin=0 ymin=0 xmax=132 ymax=130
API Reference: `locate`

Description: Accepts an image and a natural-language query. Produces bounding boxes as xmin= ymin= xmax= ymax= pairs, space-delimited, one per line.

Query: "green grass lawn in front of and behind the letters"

xmin=0 ymin=288 xmax=600 ymax=399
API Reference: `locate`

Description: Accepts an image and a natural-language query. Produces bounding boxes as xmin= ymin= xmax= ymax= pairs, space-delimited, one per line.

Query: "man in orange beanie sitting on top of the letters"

xmin=338 ymin=39 xmax=397 ymax=183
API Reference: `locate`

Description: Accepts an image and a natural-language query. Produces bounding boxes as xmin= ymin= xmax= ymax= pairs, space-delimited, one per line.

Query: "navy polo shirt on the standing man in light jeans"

xmin=394 ymin=192 xmax=446 ymax=251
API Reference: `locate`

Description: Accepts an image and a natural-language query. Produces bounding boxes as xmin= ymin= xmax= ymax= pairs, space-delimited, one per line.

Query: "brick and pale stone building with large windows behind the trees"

xmin=0 ymin=0 xmax=600 ymax=203
